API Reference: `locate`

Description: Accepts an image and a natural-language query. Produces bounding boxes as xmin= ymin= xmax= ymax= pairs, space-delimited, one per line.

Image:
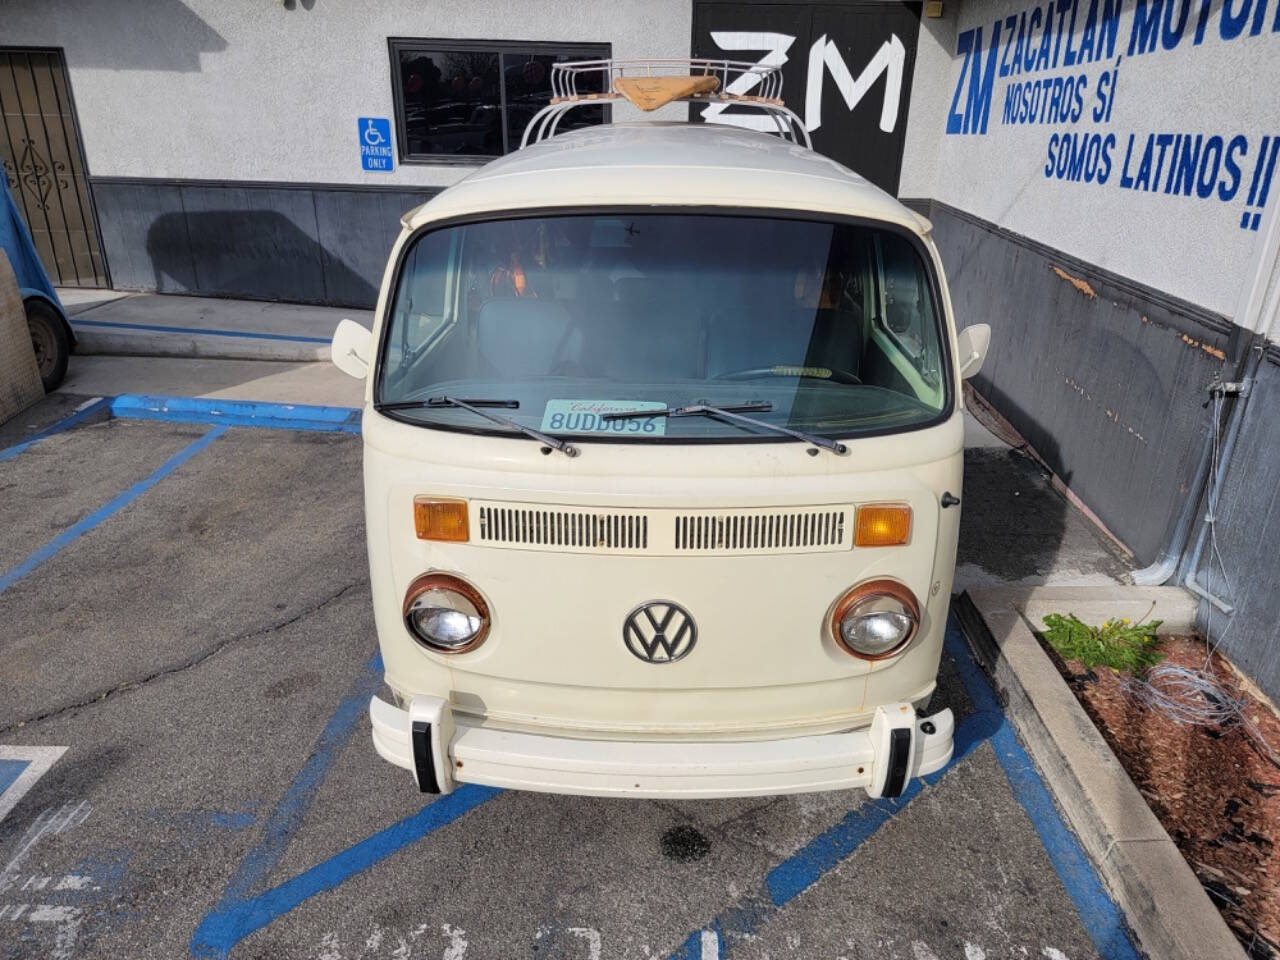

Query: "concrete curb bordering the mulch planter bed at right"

xmin=956 ymin=586 xmax=1245 ymax=960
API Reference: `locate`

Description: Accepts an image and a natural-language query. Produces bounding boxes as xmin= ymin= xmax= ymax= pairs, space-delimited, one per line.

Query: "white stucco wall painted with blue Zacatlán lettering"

xmin=900 ymin=0 xmax=1280 ymax=316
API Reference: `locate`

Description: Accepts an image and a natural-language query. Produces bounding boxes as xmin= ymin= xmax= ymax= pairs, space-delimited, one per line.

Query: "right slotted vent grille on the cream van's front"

xmin=676 ymin=509 xmax=845 ymax=552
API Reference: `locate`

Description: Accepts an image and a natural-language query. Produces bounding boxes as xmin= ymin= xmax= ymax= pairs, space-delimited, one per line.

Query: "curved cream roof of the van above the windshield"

xmin=404 ymin=122 xmax=929 ymax=236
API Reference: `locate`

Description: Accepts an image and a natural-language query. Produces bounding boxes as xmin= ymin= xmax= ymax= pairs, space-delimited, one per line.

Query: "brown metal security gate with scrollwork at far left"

xmin=0 ymin=49 xmax=108 ymax=287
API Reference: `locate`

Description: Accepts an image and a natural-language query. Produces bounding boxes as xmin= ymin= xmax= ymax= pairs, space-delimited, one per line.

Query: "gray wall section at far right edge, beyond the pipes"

xmin=1197 ymin=348 xmax=1280 ymax=700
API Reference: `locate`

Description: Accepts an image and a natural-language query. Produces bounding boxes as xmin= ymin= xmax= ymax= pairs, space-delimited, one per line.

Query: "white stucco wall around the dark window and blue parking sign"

xmin=0 ymin=0 xmax=692 ymax=186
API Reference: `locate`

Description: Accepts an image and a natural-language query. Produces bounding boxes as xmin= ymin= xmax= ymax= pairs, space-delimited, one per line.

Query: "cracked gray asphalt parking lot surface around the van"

xmin=0 ymin=396 xmax=1141 ymax=960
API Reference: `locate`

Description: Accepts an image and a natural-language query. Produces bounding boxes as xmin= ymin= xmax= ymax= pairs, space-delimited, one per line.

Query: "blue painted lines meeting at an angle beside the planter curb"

xmin=672 ymin=617 xmax=1139 ymax=960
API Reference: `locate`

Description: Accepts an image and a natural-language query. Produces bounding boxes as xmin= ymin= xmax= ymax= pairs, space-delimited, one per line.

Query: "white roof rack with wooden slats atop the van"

xmin=520 ymin=59 xmax=813 ymax=150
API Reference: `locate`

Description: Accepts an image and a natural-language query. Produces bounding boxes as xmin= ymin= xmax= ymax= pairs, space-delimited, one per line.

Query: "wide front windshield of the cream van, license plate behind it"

xmin=376 ymin=212 xmax=950 ymax=442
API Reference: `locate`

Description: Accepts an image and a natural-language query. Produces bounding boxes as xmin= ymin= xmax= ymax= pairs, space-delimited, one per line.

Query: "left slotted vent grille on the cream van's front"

xmin=480 ymin=506 xmax=649 ymax=552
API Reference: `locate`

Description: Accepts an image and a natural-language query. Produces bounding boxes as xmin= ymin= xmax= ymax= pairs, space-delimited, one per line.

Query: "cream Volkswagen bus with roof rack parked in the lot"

xmin=333 ymin=61 xmax=987 ymax=797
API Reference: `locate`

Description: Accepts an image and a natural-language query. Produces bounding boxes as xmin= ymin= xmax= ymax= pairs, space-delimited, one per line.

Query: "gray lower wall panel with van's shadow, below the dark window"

xmin=92 ymin=178 xmax=436 ymax=307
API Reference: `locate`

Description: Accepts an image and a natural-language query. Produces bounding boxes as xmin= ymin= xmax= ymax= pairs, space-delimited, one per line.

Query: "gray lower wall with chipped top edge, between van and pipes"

xmin=929 ymin=204 xmax=1234 ymax=563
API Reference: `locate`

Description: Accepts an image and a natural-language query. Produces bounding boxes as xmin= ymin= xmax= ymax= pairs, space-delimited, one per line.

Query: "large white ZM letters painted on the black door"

xmin=701 ymin=31 xmax=906 ymax=133
